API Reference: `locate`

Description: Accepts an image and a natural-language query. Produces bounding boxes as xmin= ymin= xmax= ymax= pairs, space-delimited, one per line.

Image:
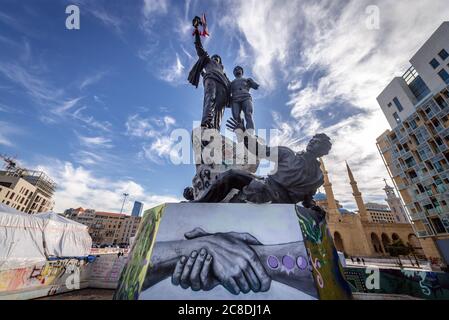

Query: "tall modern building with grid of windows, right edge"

xmin=377 ymin=22 xmax=449 ymax=263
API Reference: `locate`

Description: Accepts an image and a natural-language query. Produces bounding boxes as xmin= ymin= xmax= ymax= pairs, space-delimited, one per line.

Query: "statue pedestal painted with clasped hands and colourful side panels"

xmin=115 ymin=204 xmax=351 ymax=299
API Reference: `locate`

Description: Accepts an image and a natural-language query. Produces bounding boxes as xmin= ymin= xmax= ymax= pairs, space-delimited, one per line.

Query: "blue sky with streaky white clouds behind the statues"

xmin=0 ymin=0 xmax=449 ymax=212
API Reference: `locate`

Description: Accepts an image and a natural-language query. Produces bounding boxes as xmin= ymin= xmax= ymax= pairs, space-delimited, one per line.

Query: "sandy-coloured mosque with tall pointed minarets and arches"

xmin=315 ymin=159 xmax=426 ymax=258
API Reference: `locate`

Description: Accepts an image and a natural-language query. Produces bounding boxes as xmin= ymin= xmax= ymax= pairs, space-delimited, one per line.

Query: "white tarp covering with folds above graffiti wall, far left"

xmin=0 ymin=208 xmax=92 ymax=270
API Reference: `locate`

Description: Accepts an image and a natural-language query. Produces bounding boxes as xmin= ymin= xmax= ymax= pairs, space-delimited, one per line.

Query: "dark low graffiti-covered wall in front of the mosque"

xmin=344 ymin=268 xmax=449 ymax=300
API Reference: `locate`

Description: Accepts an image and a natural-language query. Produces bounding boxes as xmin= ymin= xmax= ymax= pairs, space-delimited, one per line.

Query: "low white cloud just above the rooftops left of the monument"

xmin=38 ymin=161 xmax=180 ymax=213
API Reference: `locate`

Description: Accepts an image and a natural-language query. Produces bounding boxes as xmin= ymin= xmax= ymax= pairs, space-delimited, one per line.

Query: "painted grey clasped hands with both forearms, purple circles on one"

xmin=142 ymin=228 xmax=317 ymax=297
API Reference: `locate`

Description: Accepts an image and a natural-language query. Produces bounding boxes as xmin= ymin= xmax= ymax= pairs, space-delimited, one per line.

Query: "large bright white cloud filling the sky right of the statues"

xmin=231 ymin=0 xmax=449 ymax=208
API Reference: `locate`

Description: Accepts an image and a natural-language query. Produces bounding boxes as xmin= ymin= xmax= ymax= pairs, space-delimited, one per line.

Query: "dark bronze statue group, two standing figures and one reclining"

xmin=185 ymin=17 xmax=332 ymax=209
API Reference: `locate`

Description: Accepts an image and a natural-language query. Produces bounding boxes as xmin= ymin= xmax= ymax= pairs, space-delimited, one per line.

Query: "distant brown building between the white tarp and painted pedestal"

xmin=64 ymin=208 xmax=141 ymax=245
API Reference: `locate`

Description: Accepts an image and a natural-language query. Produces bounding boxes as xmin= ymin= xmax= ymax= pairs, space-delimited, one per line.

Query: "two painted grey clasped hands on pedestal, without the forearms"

xmin=172 ymin=228 xmax=271 ymax=295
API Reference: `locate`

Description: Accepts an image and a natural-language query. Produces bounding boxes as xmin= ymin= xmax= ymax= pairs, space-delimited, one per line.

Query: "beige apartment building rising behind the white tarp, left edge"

xmin=0 ymin=169 xmax=56 ymax=214
